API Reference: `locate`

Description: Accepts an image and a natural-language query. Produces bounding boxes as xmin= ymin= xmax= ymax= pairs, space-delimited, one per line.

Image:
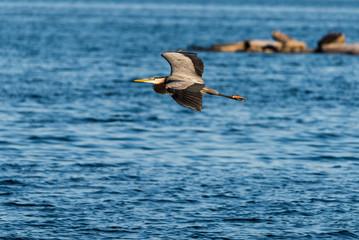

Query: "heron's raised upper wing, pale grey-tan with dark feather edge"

xmin=161 ymin=52 xmax=204 ymax=83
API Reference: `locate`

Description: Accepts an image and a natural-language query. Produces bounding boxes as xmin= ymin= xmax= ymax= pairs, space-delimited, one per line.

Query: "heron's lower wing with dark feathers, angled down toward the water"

xmin=166 ymin=81 xmax=205 ymax=112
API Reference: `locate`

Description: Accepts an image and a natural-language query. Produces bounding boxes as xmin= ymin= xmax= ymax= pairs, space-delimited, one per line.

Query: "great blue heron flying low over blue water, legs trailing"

xmin=134 ymin=52 xmax=246 ymax=112
